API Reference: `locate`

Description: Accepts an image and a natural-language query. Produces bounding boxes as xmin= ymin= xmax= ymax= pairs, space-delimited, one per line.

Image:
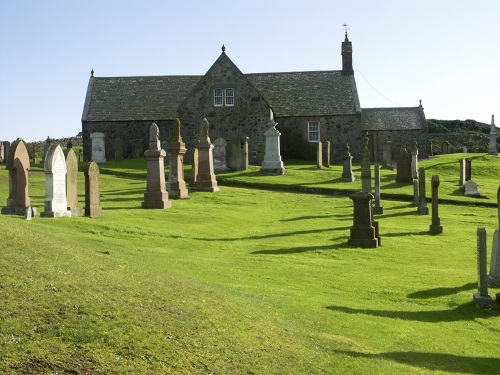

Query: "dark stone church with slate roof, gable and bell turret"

xmin=82 ymin=34 xmax=428 ymax=165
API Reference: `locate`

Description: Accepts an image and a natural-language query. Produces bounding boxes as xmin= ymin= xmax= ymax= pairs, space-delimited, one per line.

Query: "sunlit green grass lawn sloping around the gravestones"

xmin=0 ymin=154 xmax=500 ymax=374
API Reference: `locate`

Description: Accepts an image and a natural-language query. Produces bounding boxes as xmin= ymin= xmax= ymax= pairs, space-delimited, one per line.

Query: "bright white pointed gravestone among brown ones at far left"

xmin=42 ymin=143 xmax=71 ymax=217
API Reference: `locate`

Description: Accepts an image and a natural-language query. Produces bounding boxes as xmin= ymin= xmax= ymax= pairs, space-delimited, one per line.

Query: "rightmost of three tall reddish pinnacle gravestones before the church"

xmin=194 ymin=118 xmax=219 ymax=192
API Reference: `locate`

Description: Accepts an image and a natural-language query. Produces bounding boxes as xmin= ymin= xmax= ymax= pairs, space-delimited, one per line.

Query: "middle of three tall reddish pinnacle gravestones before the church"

xmin=167 ymin=118 xmax=189 ymax=199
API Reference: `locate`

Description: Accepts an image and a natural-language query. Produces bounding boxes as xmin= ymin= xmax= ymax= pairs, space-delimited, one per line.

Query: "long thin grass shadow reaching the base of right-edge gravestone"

xmin=326 ymin=302 xmax=500 ymax=323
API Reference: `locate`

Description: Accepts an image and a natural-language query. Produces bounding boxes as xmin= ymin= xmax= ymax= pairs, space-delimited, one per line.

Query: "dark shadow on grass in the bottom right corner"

xmin=338 ymin=350 xmax=500 ymax=375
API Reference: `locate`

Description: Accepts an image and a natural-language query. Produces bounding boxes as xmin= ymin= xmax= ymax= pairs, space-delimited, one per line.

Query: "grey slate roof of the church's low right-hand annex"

xmin=361 ymin=107 xmax=426 ymax=130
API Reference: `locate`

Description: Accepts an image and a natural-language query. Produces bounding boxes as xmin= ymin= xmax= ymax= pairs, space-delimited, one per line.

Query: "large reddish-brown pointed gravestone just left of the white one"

xmin=2 ymin=138 xmax=36 ymax=216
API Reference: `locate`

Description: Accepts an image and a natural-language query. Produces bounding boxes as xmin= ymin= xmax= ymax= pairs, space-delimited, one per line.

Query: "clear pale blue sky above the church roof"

xmin=0 ymin=0 xmax=500 ymax=141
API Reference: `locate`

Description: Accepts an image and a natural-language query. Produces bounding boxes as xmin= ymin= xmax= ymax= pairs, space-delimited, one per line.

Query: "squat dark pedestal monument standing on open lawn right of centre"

xmin=348 ymin=191 xmax=379 ymax=248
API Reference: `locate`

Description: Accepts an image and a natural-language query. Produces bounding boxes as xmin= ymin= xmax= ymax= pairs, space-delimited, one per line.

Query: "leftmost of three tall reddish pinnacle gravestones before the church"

xmin=142 ymin=122 xmax=172 ymax=209
